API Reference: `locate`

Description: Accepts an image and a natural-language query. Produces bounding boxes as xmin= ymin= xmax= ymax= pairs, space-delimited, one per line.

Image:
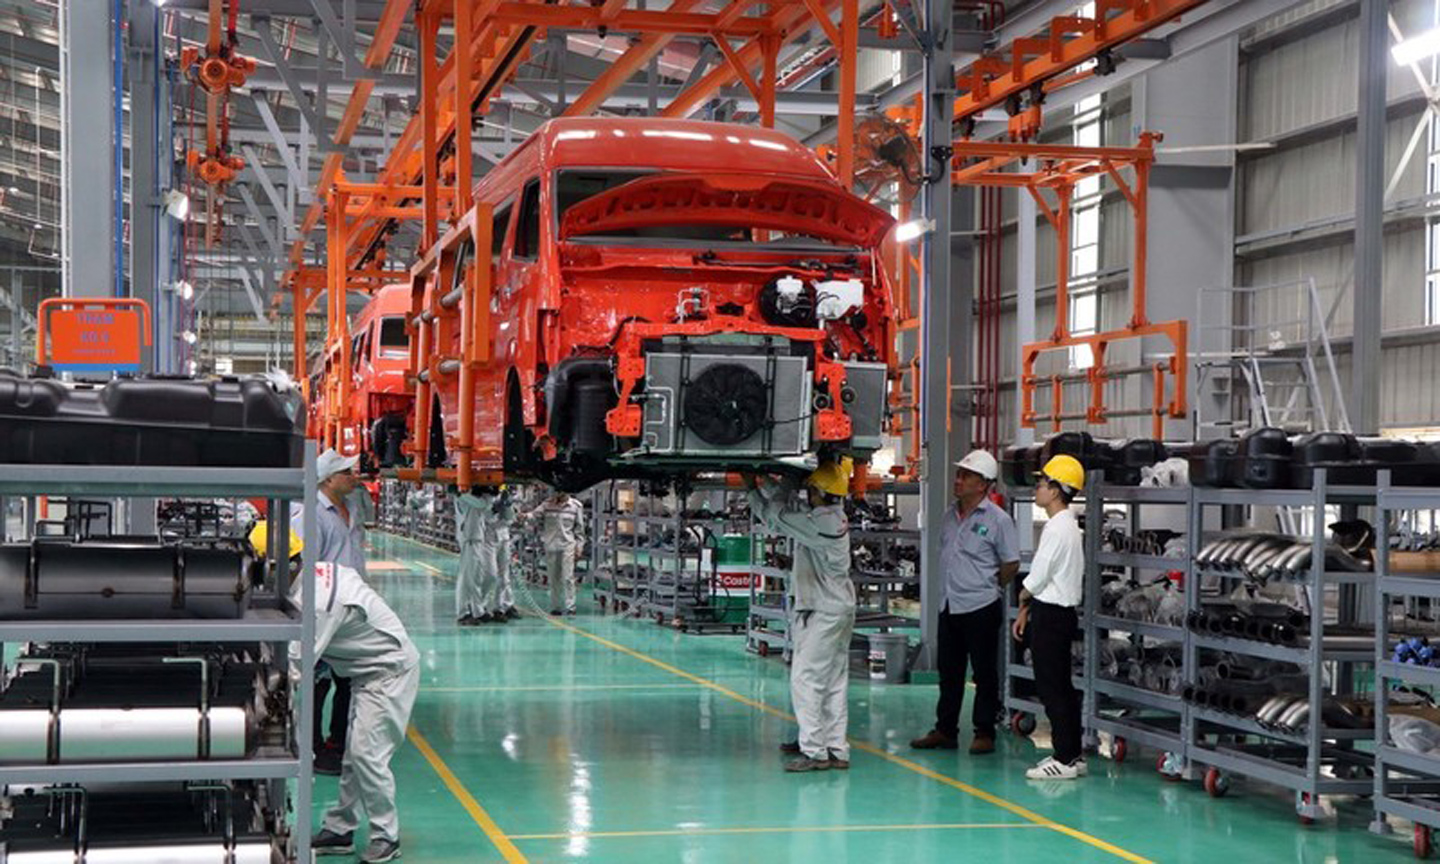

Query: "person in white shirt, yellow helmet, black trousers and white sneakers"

xmin=1012 ymin=455 xmax=1087 ymax=780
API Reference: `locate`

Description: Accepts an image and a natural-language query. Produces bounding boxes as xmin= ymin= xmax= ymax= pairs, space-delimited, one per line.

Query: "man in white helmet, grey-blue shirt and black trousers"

xmin=910 ymin=449 xmax=1020 ymax=755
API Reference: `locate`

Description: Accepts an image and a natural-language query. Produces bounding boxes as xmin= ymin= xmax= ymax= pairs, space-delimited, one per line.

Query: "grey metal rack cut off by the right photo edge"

xmin=1371 ymin=471 xmax=1440 ymax=854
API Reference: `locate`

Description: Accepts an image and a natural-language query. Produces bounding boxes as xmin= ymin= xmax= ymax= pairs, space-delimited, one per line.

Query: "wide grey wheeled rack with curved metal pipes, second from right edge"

xmin=1184 ymin=469 xmax=1375 ymax=821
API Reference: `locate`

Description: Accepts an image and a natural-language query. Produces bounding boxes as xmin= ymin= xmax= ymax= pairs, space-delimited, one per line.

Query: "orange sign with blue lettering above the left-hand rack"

xmin=35 ymin=297 xmax=150 ymax=372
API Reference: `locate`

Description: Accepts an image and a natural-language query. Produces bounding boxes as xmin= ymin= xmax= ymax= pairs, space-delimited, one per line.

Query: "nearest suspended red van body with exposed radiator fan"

xmin=412 ymin=118 xmax=894 ymax=488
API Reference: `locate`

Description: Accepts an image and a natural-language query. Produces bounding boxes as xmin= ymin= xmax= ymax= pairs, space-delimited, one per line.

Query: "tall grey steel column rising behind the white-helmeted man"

xmin=917 ymin=0 xmax=955 ymax=670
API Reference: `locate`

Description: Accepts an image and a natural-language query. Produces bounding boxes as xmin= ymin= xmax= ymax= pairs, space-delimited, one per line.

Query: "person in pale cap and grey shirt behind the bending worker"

xmin=289 ymin=448 xmax=370 ymax=776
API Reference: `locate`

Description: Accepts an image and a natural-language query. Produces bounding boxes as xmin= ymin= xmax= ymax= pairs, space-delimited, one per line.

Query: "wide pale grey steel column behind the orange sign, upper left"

xmin=60 ymin=0 xmax=120 ymax=297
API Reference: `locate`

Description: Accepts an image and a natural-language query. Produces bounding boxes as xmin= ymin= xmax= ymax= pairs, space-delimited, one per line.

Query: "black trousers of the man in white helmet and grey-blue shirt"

xmin=935 ymin=600 xmax=1005 ymax=737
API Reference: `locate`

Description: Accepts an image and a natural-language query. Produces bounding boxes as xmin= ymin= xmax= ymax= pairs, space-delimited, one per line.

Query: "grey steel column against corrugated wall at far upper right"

xmin=1349 ymin=0 xmax=1390 ymax=435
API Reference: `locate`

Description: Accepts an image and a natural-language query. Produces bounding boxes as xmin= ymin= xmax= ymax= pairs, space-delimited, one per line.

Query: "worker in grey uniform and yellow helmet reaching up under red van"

xmin=746 ymin=459 xmax=855 ymax=772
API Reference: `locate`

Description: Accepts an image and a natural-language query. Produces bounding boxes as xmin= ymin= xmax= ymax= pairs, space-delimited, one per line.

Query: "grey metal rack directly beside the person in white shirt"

xmin=1081 ymin=486 xmax=1194 ymax=762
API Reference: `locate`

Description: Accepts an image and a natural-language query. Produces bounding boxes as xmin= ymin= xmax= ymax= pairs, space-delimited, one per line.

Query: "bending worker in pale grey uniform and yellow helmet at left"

xmin=251 ymin=523 xmax=420 ymax=864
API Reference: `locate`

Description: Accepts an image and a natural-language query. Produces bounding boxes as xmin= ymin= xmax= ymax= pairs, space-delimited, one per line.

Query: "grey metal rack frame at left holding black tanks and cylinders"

xmin=0 ymin=455 xmax=317 ymax=861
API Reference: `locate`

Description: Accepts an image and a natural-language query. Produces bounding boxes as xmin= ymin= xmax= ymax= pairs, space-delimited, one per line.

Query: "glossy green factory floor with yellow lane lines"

xmin=351 ymin=534 xmax=1411 ymax=864
